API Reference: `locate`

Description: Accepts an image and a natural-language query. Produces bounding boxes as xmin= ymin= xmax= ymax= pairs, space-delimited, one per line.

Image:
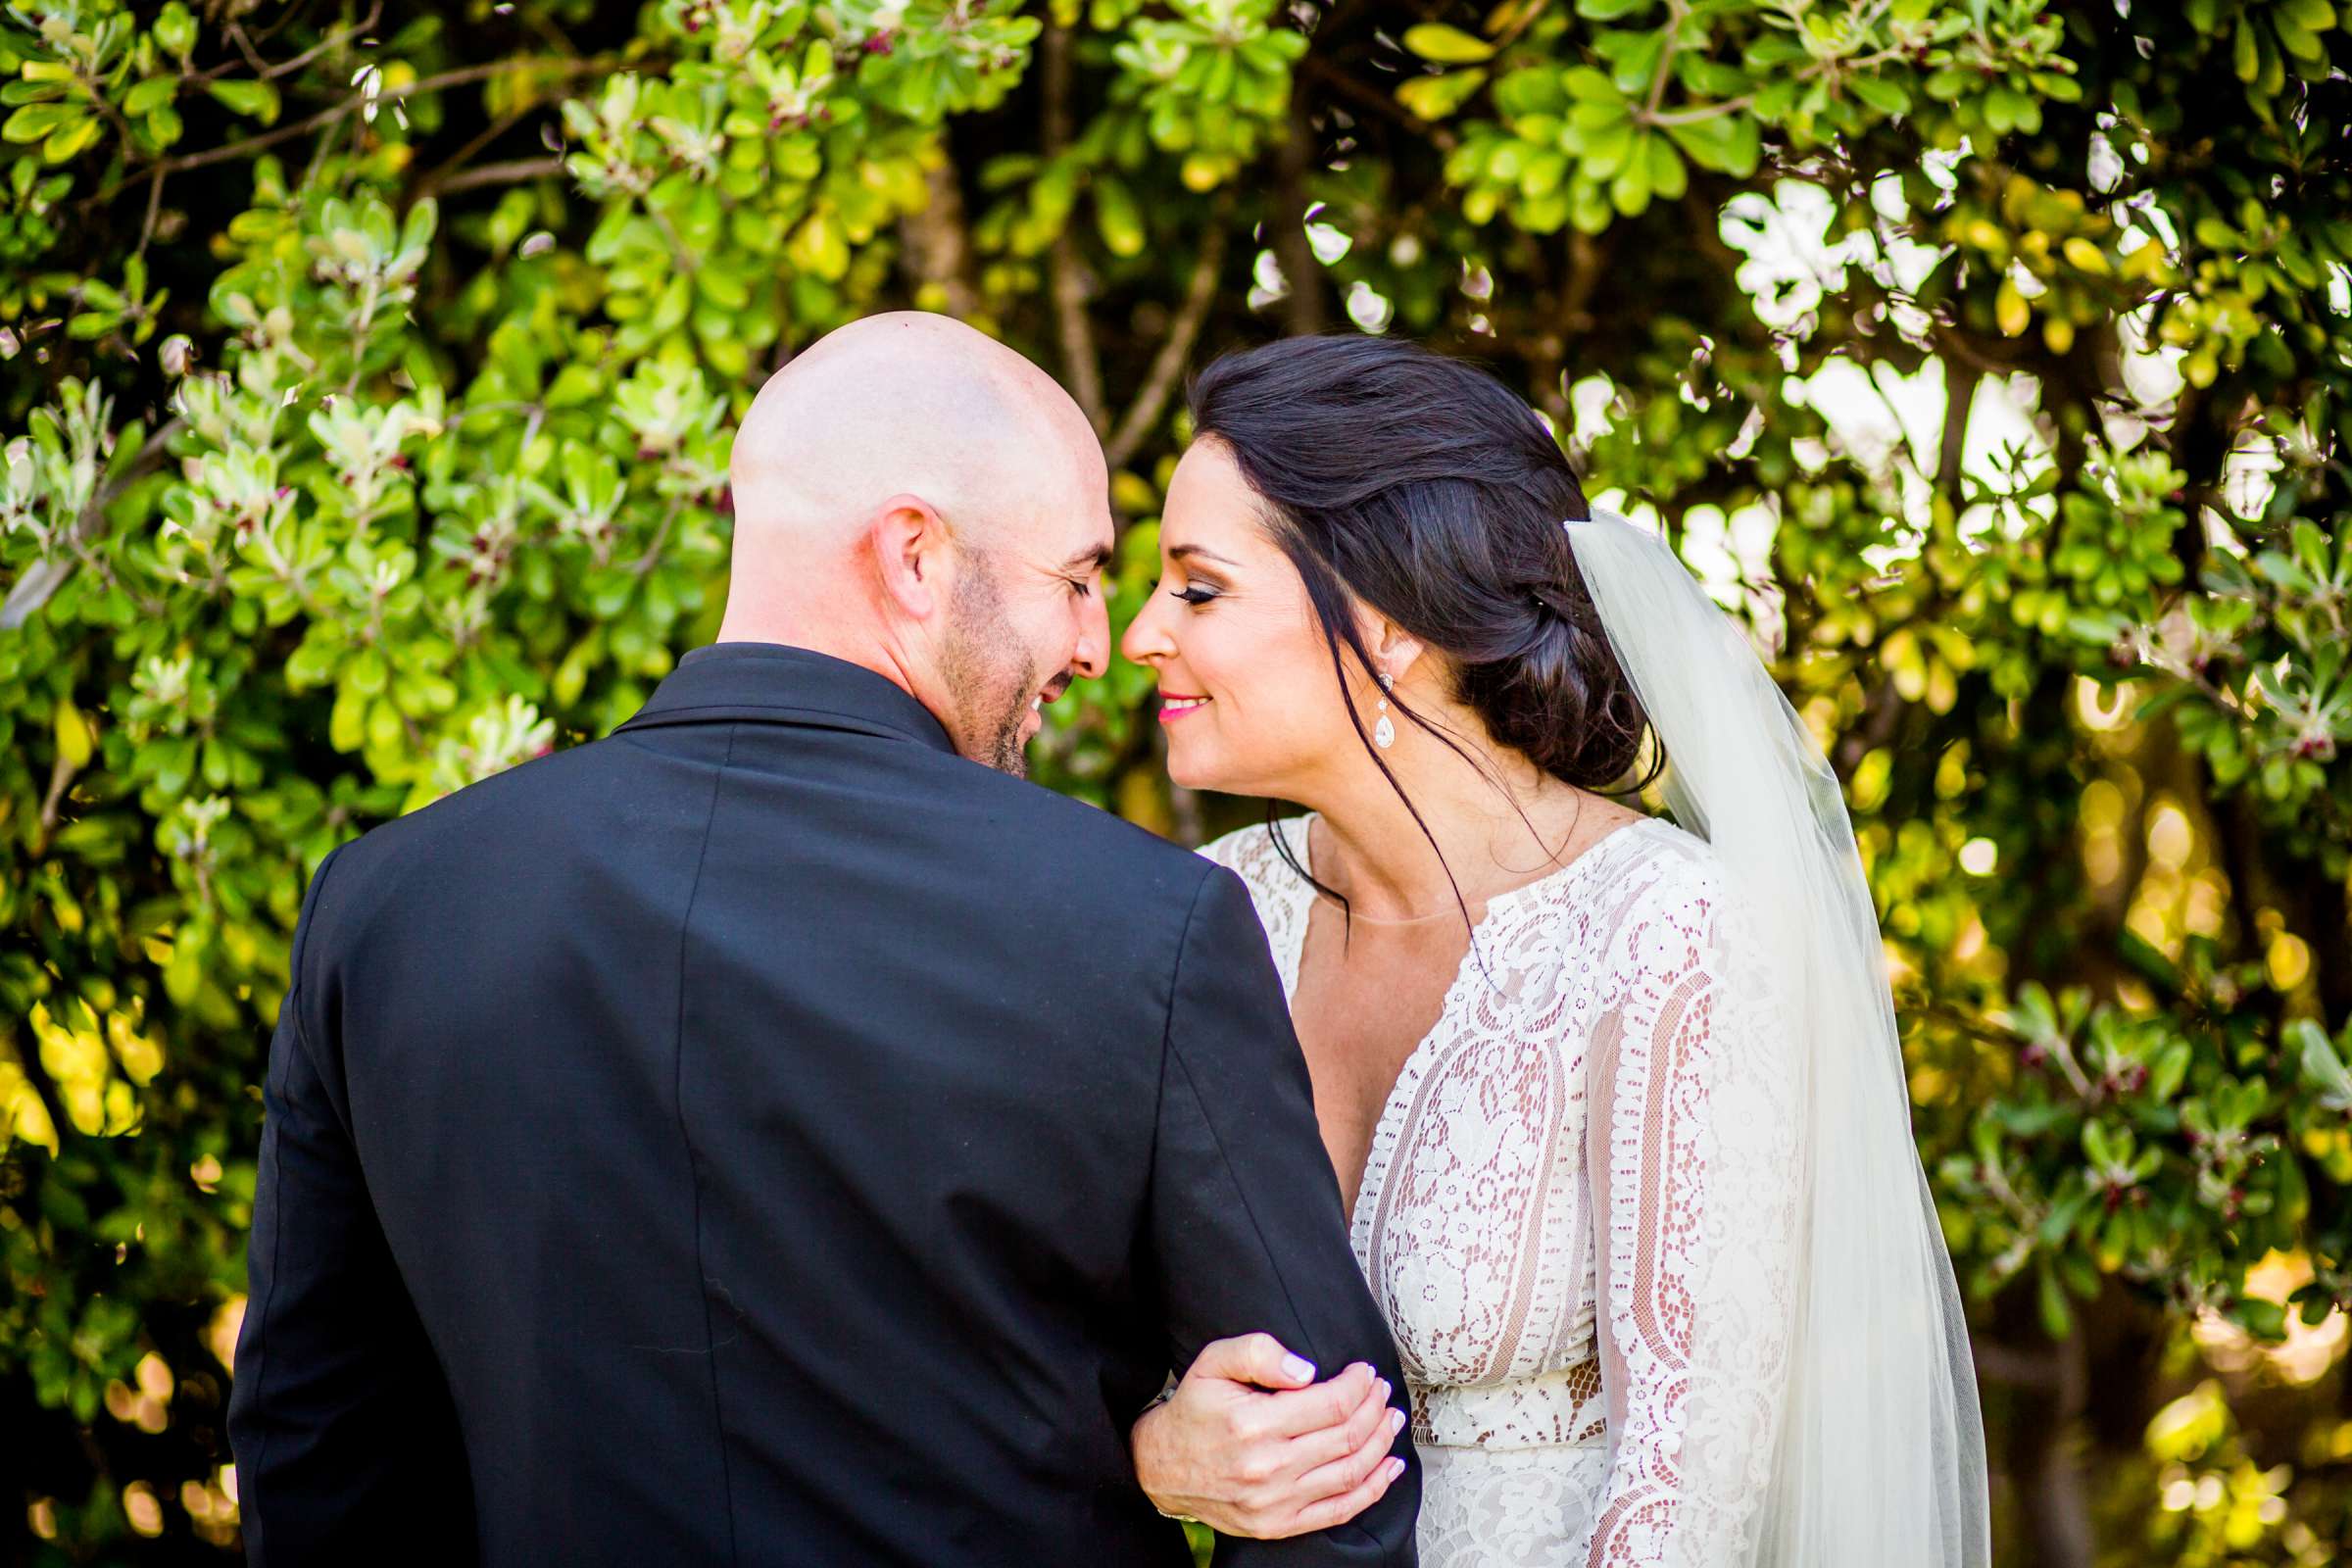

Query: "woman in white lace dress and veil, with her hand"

xmin=1124 ymin=338 xmax=1989 ymax=1568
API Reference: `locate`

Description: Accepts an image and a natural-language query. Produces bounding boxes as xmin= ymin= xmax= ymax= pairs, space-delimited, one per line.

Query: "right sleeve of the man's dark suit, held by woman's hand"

xmin=1151 ymin=867 xmax=1421 ymax=1568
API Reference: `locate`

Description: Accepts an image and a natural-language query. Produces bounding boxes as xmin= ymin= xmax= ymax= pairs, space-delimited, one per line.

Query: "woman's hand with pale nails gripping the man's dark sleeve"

xmin=1129 ymin=1333 xmax=1404 ymax=1540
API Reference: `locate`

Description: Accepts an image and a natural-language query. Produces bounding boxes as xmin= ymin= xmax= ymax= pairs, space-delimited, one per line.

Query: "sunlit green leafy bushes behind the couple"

xmin=0 ymin=0 xmax=2352 ymax=1566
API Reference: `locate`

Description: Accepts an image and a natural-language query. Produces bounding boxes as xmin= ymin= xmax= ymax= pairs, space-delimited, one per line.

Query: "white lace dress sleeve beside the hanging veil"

xmin=1588 ymin=856 xmax=1799 ymax=1568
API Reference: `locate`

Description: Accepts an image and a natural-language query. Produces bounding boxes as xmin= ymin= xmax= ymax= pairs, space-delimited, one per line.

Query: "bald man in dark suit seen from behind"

xmin=230 ymin=315 xmax=1418 ymax=1568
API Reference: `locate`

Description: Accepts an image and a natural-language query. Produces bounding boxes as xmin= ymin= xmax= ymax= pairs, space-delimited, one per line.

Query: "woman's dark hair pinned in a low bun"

xmin=1188 ymin=336 xmax=1658 ymax=921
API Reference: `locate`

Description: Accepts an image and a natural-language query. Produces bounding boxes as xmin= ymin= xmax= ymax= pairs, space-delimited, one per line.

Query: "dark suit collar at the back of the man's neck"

xmin=621 ymin=642 xmax=955 ymax=755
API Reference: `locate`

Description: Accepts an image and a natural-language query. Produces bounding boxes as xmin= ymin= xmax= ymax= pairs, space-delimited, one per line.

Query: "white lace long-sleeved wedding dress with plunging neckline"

xmin=1201 ymin=818 xmax=1799 ymax=1568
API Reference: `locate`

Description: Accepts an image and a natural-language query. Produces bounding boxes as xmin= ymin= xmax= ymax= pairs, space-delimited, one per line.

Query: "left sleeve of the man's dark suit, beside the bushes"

xmin=228 ymin=851 xmax=472 ymax=1568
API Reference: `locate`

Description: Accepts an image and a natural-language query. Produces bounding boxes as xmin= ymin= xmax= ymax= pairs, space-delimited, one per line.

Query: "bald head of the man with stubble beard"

xmin=719 ymin=313 xmax=1110 ymax=771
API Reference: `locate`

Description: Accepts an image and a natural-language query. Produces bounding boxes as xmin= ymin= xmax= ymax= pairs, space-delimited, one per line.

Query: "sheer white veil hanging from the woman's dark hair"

xmin=1566 ymin=511 xmax=1992 ymax=1568
